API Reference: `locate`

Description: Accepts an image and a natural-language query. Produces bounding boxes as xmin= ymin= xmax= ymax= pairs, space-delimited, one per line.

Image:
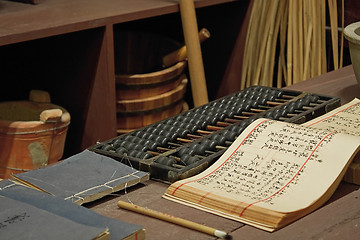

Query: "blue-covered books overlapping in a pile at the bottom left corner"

xmin=0 ymin=180 xmax=145 ymax=240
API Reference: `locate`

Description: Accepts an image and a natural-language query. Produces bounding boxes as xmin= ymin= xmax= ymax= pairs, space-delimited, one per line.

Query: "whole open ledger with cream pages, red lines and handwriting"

xmin=163 ymin=99 xmax=360 ymax=231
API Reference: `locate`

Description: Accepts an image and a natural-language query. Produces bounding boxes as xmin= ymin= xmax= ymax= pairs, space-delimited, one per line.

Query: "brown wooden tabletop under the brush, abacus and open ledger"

xmin=86 ymin=66 xmax=360 ymax=240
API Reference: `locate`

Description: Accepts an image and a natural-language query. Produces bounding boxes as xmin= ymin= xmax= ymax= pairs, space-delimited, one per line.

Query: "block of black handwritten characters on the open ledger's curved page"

xmin=196 ymin=120 xmax=332 ymax=205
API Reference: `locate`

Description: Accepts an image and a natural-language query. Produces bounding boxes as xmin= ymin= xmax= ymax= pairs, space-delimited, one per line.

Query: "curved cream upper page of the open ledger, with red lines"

xmin=167 ymin=119 xmax=360 ymax=213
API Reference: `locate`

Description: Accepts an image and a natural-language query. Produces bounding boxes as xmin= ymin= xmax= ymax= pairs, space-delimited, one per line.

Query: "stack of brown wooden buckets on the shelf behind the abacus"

xmin=114 ymin=32 xmax=187 ymax=133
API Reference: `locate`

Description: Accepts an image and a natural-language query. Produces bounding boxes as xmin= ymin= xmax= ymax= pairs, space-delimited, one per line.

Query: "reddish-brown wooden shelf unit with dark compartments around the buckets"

xmin=0 ymin=0 xmax=250 ymax=157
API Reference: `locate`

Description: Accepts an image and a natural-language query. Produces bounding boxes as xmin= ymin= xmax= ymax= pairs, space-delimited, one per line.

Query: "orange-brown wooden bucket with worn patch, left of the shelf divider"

xmin=0 ymin=91 xmax=70 ymax=178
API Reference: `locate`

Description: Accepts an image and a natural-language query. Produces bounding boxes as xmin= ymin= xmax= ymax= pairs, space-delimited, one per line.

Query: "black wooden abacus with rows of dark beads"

xmin=89 ymin=86 xmax=340 ymax=183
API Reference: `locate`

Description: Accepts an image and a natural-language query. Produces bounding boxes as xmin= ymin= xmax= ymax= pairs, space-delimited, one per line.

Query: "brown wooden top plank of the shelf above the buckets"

xmin=0 ymin=0 xmax=236 ymax=46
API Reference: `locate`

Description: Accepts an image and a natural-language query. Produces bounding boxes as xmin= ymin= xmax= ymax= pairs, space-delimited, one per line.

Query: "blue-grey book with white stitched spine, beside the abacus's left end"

xmin=13 ymin=150 xmax=149 ymax=205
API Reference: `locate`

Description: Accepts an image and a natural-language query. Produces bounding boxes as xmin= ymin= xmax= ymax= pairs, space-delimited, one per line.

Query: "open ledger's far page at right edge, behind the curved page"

xmin=303 ymin=98 xmax=360 ymax=136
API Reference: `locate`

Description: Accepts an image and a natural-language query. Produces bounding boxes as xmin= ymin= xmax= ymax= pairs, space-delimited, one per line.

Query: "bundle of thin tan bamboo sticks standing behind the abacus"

xmin=241 ymin=0 xmax=344 ymax=87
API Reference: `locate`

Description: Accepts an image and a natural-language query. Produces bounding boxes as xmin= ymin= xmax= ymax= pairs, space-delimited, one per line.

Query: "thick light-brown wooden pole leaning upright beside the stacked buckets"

xmin=179 ymin=0 xmax=209 ymax=107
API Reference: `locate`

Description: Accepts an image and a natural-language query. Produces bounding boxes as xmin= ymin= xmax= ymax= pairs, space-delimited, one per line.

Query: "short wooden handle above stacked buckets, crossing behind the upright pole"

xmin=162 ymin=28 xmax=210 ymax=67
